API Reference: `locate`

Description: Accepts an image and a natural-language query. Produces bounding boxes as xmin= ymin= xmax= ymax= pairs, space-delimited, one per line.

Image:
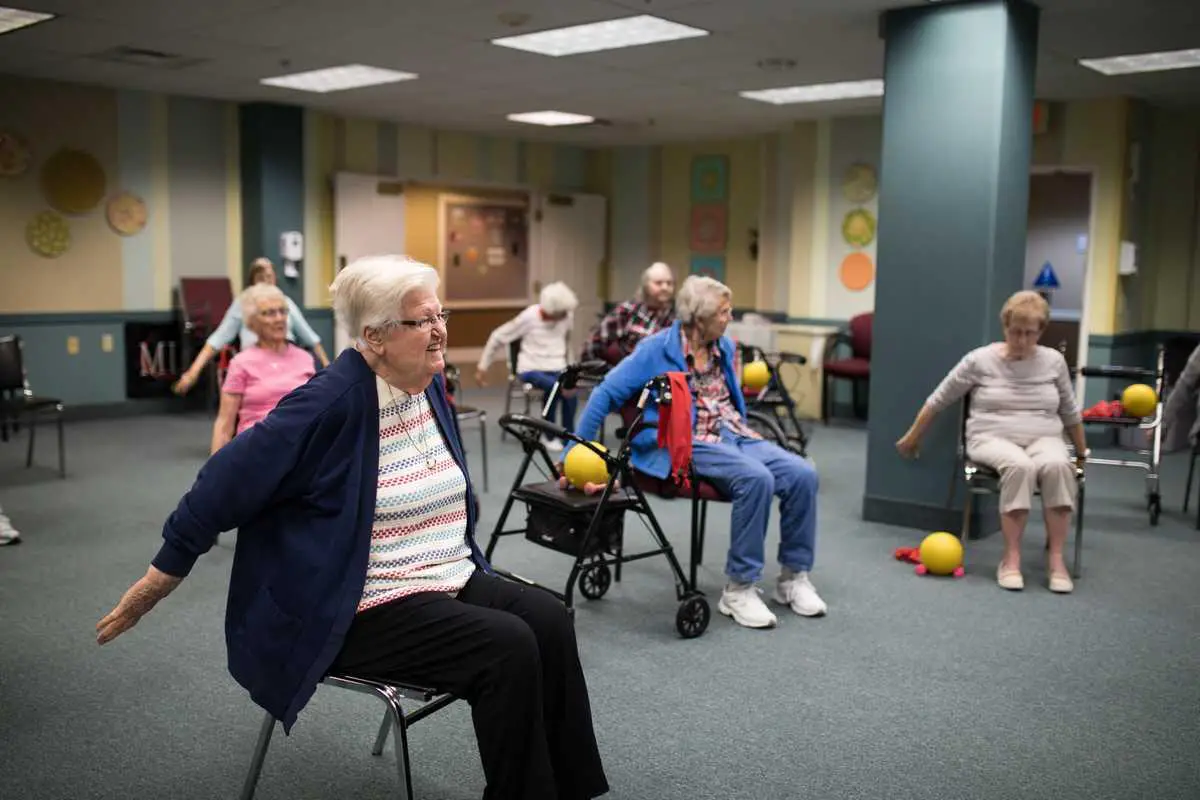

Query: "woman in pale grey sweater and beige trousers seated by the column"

xmin=896 ymin=291 xmax=1087 ymax=594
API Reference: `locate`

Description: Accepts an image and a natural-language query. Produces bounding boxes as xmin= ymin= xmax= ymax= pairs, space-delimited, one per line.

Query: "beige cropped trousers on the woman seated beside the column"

xmin=967 ymin=437 xmax=1079 ymax=513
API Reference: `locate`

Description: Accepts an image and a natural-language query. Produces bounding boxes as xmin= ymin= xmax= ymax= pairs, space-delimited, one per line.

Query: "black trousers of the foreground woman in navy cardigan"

xmin=334 ymin=571 xmax=608 ymax=800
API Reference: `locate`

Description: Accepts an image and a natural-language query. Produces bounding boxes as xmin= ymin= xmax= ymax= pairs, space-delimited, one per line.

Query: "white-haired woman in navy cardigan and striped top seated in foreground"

xmin=96 ymin=257 xmax=607 ymax=800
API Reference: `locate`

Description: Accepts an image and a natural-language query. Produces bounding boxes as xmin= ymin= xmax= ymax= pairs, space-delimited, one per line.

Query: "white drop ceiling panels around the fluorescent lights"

xmin=0 ymin=0 xmax=1200 ymax=145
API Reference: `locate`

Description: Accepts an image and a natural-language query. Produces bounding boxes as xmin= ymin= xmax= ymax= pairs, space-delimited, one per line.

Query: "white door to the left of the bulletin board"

xmin=331 ymin=173 xmax=406 ymax=355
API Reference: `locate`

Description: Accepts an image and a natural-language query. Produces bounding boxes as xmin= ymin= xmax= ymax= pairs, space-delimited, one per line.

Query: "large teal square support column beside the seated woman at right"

xmin=863 ymin=0 xmax=1038 ymax=531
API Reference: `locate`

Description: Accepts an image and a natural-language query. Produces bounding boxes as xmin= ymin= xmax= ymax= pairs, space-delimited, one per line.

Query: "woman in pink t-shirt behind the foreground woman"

xmin=212 ymin=283 xmax=316 ymax=452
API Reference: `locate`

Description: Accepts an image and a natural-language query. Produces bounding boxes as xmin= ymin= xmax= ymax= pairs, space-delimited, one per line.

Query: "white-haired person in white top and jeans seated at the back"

xmin=475 ymin=281 xmax=580 ymax=450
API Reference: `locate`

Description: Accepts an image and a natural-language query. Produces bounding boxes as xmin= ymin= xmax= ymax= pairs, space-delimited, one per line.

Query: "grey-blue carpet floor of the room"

xmin=0 ymin=395 xmax=1200 ymax=800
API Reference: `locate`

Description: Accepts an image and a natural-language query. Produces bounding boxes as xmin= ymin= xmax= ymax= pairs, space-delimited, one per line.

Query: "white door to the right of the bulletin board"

xmin=529 ymin=194 xmax=607 ymax=361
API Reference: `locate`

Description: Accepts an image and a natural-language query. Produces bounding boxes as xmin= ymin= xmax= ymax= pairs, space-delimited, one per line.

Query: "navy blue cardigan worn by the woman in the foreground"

xmin=154 ymin=350 xmax=488 ymax=730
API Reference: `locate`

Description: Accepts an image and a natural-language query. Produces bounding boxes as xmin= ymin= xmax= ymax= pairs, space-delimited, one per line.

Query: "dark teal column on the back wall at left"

xmin=238 ymin=103 xmax=304 ymax=308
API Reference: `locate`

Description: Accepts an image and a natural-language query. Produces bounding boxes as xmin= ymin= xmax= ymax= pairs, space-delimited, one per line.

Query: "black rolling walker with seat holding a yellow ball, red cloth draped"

xmin=485 ymin=362 xmax=712 ymax=639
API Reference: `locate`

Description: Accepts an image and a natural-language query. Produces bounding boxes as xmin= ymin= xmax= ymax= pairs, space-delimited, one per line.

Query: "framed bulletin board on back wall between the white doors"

xmin=439 ymin=194 xmax=529 ymax=307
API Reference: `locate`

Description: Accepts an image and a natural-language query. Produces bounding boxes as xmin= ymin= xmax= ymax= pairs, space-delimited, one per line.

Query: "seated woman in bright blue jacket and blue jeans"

xmin=577 ymin=275 xmax=826 ymax=627
